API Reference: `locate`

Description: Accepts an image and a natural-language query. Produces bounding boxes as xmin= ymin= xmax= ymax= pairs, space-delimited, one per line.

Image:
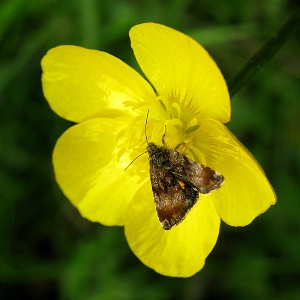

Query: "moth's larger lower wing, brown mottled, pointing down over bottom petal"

xmin=150 ymin=166 xmax=199 ymax=230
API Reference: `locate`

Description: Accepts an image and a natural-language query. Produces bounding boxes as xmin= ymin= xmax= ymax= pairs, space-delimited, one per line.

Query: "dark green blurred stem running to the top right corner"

xmin=228 ymin=8 xmax=300 ymax=97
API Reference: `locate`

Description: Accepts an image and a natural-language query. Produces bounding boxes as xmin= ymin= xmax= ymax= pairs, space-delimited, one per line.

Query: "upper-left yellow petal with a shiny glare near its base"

xmin=42 ymin=46 xmax=154 ymax=122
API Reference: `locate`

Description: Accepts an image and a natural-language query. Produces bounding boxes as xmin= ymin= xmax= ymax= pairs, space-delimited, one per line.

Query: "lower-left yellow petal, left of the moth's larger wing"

xmin=53 ymin=118 xmax=141 ymax=225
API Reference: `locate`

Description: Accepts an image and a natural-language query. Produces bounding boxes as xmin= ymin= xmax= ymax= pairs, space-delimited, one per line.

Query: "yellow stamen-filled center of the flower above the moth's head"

xmin=118 ymin=96 xmax=201 ymax=176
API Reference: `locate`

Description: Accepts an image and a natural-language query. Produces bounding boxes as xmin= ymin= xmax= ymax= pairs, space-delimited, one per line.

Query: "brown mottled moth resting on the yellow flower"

xmin=147 ymin=136 xmax=224 ymax=230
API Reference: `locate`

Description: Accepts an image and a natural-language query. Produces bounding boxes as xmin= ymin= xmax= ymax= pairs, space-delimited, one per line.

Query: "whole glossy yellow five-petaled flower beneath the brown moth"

xmin=42 ymin=23 xmax=276 ymax=277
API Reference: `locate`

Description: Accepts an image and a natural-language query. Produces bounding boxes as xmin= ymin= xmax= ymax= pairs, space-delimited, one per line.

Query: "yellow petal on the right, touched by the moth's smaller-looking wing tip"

xmin=198 ymin=120 xmax=276 ymax=226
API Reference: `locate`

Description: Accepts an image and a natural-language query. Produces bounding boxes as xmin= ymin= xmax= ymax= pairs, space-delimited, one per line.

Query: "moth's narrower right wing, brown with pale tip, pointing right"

xmin=170 ymin=149 xmax=224 ymax=194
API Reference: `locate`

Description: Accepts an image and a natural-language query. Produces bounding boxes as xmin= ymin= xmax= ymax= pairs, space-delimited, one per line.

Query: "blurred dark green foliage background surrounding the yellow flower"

xmin=0 ymin=0 xmax=300 ymax=300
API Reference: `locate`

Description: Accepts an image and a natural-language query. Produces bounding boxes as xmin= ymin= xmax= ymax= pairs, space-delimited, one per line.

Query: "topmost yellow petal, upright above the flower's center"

xmin=129 ymin=23 xmax=230 ymax=123
